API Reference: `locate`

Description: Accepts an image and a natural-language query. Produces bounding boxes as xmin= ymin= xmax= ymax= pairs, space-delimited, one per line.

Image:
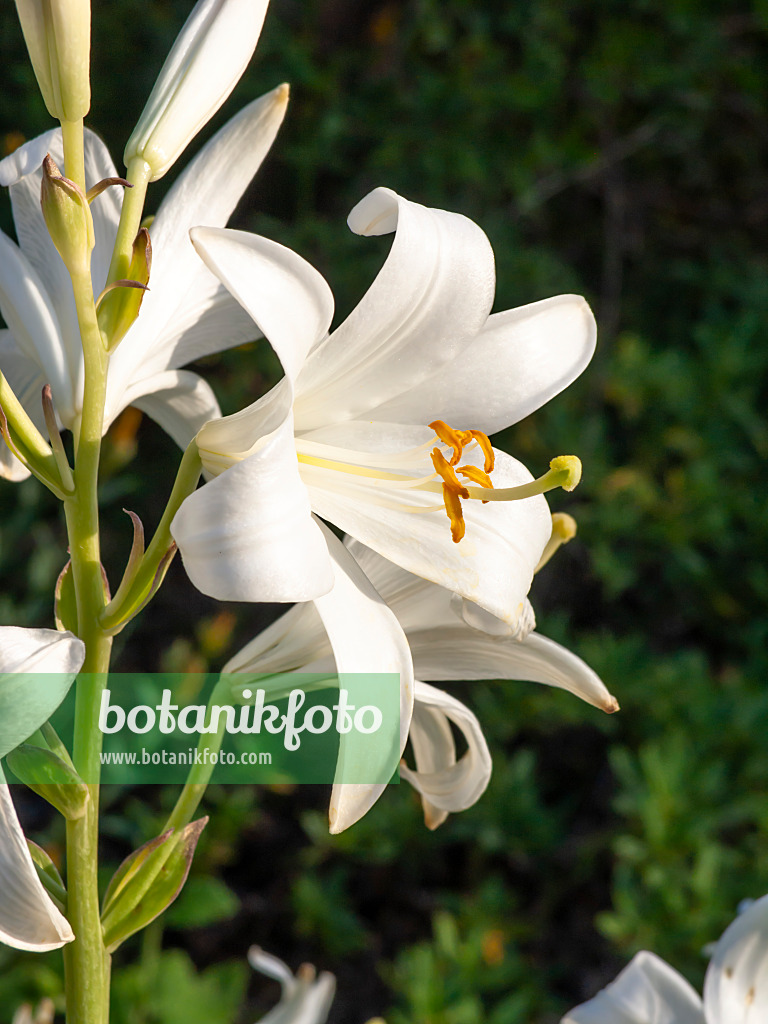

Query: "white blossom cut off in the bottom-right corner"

xmin=562 ymin=896 xmax=768 ymax=1024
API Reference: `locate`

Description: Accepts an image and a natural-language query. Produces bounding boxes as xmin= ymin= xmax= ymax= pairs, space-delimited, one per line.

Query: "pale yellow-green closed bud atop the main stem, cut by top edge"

xmin=16 ymin=0 xmax=91 ymax=121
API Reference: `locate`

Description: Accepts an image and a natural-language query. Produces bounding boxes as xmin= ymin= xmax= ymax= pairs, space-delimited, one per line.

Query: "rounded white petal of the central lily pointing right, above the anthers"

xmin=370 ymin=295 xmax=597 ymax=434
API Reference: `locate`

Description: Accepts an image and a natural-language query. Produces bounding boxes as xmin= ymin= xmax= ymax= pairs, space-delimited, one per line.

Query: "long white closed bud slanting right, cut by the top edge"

xmin=124 ymin=0 xmax=268 ymax=181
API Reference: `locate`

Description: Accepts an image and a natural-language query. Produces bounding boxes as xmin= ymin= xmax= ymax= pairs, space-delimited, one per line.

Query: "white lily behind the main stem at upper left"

xmin=0 ymin=85 xmax=288 ymax=479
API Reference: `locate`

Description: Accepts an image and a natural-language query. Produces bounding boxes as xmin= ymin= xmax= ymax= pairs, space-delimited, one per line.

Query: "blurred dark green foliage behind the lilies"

xmin=0 ymin=0 xmax=768 ymax=1024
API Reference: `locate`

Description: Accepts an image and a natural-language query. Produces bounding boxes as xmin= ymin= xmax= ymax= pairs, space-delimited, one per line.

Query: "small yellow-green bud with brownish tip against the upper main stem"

xmin=40 ymin=156 xmax=94 ymax=273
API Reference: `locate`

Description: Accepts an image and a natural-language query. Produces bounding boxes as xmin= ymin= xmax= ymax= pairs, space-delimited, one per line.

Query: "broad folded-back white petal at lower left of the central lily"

xmin=171 ymin=414 xmax=334 ymax=601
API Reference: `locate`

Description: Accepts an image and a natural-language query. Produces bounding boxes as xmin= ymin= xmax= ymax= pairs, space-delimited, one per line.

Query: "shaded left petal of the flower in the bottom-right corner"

xmin=561 ymin=951 xmax=708 ymax=1024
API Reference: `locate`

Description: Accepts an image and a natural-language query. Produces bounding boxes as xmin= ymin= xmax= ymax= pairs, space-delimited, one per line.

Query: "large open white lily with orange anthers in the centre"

xmin=172 ymin=188 xmax=595 ymax=625
